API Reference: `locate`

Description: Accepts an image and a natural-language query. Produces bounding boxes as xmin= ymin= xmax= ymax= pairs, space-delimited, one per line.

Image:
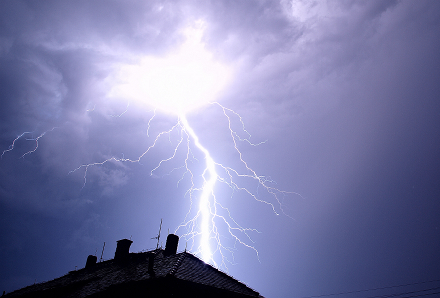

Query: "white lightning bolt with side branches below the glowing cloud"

xmin=70 ymin=102 xmax=301 ymax=270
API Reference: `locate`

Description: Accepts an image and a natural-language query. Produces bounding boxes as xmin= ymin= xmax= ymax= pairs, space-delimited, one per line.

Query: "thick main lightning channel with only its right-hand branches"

xmin=176 ymin=102 xmax=302 ymax=269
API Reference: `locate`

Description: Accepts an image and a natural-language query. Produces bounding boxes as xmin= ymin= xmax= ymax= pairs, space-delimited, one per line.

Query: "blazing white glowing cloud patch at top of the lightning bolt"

xmin=109 ymin=22 xmax=231 ymax=115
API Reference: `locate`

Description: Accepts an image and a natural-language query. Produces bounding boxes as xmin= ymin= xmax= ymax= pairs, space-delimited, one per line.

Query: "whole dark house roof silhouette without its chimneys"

xmin=5 ymin=249 xmax=262 ymax=297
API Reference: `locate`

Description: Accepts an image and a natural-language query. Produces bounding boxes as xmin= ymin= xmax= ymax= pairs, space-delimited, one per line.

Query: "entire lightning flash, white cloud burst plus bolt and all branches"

xmin=1 ymin=24 xmax=301 ymax=269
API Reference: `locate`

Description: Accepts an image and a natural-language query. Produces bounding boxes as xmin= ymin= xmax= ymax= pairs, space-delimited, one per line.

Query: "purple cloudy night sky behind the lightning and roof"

xmin=0 ymin=0 xmax=440 ymax=297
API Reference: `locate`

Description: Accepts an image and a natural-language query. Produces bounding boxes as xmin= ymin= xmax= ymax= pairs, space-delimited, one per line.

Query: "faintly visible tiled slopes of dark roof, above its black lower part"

xmin=7 ymin=249 xmax=262 ymax=297
